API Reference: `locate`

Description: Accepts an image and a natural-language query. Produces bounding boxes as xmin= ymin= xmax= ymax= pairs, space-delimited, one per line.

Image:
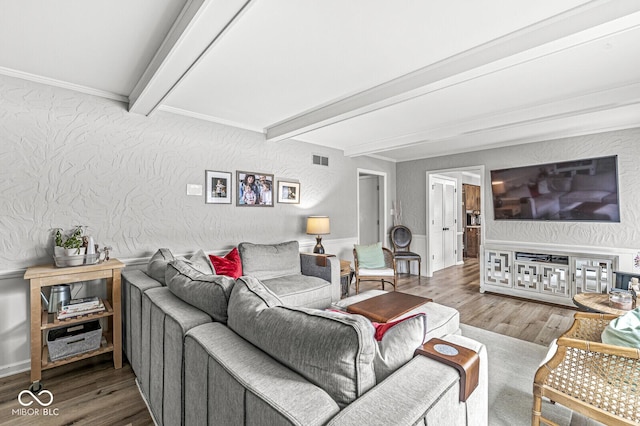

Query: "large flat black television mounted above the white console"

xmin=491 ymin=155 xmax=620 ymax=222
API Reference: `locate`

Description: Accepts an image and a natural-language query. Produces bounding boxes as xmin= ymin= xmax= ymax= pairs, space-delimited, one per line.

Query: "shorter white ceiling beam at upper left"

xmin=129 ymin=0 xmax=251 ymax=115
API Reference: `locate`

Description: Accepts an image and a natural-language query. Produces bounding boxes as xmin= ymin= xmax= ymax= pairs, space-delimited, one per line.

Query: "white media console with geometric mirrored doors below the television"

xmin=480 ymin=245 xmax=618 ymax=306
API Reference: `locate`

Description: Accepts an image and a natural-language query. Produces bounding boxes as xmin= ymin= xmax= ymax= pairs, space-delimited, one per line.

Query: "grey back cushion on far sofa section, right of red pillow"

xmin=238 ymin=241 xmax=302 ymax=280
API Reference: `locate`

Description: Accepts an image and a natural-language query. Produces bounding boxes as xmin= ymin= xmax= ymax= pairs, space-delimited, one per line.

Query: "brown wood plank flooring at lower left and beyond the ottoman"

xmin=0 ymin=259 xmax=575 ymax=426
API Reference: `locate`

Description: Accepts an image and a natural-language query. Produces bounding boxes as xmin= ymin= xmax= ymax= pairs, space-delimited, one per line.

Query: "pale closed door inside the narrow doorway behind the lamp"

xmin=358 ymin=175 xmax=381 ymax=244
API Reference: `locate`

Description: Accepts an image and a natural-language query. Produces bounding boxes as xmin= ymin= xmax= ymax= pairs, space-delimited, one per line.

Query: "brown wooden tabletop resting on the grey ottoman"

xmin=347 ymin=291 xmax=433 ymax=322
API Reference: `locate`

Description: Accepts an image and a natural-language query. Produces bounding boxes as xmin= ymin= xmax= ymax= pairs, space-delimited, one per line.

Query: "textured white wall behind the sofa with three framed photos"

xmin=0 ymin=76 xmax=396 ymax=376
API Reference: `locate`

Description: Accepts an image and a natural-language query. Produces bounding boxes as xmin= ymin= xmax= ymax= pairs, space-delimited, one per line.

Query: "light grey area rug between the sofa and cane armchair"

xmin=460 ymin=324 xmax=572 ymax=426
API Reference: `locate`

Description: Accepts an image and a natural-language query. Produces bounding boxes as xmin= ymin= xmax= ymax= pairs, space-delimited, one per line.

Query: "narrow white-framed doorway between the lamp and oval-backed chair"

xmin=357 ymin=169 xmax=387 ymax=246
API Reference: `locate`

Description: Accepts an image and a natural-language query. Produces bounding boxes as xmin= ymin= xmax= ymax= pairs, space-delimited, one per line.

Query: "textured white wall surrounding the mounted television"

xmin=396 ymin=128 xmax=640 ymax=251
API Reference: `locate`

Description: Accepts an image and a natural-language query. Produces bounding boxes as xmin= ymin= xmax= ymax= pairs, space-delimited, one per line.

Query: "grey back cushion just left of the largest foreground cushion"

xmin=166 ymin=260 xmax=235 ymax=322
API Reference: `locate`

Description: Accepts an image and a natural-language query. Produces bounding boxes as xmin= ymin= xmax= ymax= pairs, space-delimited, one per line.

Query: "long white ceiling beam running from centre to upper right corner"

xmin=265 ymin=0 xmax=640 ymax=141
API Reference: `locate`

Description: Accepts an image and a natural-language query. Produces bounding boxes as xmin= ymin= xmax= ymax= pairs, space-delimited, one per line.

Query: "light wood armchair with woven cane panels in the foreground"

xmin=531 ymin=312 xmax=640 ymax=426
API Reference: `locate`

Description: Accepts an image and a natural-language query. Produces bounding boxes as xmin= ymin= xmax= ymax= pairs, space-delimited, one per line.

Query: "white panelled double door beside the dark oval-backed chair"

xmin=429 ymin=177 xmax=457 ymax=271
